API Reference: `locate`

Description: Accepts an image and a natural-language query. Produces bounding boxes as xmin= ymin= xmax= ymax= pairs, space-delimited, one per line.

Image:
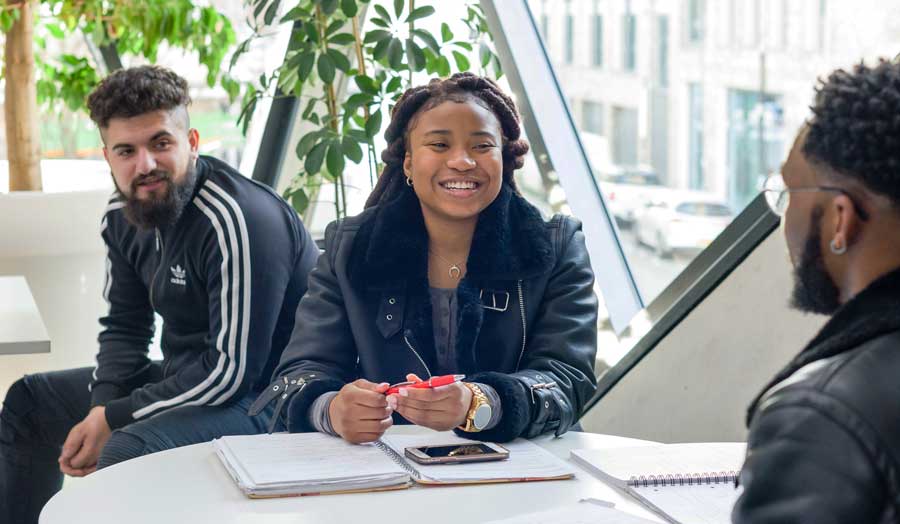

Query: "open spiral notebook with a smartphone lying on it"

xmin=213 ymin=432 xmax=574 ymax=498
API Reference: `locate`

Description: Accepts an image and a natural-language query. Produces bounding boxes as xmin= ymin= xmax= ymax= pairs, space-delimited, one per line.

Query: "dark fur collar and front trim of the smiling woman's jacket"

xmin=348 ymin=184 xmax=554 ymax=374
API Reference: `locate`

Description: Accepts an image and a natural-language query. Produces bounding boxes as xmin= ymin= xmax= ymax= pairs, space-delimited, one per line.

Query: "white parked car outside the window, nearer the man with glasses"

xmin=634 ymin=191 xmax=734 ymax=257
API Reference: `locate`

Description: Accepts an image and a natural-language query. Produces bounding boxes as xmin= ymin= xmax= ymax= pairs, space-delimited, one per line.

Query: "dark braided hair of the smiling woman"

xmin=366 ymin=73 xmax=528 ymax=208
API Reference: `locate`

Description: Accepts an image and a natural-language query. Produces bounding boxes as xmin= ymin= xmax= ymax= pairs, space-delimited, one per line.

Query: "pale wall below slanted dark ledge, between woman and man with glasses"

xmin=582 ymin=230 xmax=824 ymax=442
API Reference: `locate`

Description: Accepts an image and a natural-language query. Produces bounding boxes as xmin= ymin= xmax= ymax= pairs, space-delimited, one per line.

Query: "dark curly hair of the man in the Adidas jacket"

xmin=87 ymin=65 xmax=191 ymax=128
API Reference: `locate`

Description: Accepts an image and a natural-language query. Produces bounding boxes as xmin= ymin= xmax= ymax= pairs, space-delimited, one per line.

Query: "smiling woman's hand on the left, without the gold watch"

xmin=328 ymin=379 xmax=394 ymax=444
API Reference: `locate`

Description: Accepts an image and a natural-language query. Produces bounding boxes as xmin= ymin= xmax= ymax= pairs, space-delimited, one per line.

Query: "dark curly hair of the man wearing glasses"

xmin=803 ymin=59 xmax=900 ymax=205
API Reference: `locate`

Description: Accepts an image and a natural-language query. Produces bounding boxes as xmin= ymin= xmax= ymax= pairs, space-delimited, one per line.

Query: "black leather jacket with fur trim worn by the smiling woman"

xmin=256 ymin=184 xmax=597 ymax=441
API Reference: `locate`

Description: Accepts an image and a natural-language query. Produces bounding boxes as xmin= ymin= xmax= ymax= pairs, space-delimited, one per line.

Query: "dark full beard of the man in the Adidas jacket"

xmin=120 ymin=163 xmax=197 ymax=229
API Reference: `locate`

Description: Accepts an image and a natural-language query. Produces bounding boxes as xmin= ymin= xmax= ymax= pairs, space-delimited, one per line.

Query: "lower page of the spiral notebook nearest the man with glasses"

xmin=628 ymin=483 xmax=741 ymax=524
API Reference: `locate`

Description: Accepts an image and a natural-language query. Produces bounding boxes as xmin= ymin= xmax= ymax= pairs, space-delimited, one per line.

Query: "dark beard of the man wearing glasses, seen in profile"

xmin=791 ymin=207 xmax=841 ymax=315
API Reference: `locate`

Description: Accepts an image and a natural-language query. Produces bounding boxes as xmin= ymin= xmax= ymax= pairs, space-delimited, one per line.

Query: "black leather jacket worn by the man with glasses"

xmin=733 ymin=272 xmax=900 ymax=524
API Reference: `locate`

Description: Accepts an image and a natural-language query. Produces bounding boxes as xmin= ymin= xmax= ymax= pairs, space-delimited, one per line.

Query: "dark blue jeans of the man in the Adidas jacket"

xmin=0 ymin=368 xmax=284 ymax=524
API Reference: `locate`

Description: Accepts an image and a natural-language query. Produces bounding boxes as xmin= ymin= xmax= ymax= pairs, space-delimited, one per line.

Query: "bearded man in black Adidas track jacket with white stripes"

xmin=0 ymin=66 xmax=319 ymax=524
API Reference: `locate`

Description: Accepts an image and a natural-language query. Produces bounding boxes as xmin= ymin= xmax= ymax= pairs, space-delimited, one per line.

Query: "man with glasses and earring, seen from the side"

xmin=733 ymin=60 xmax=900 ymax=524
